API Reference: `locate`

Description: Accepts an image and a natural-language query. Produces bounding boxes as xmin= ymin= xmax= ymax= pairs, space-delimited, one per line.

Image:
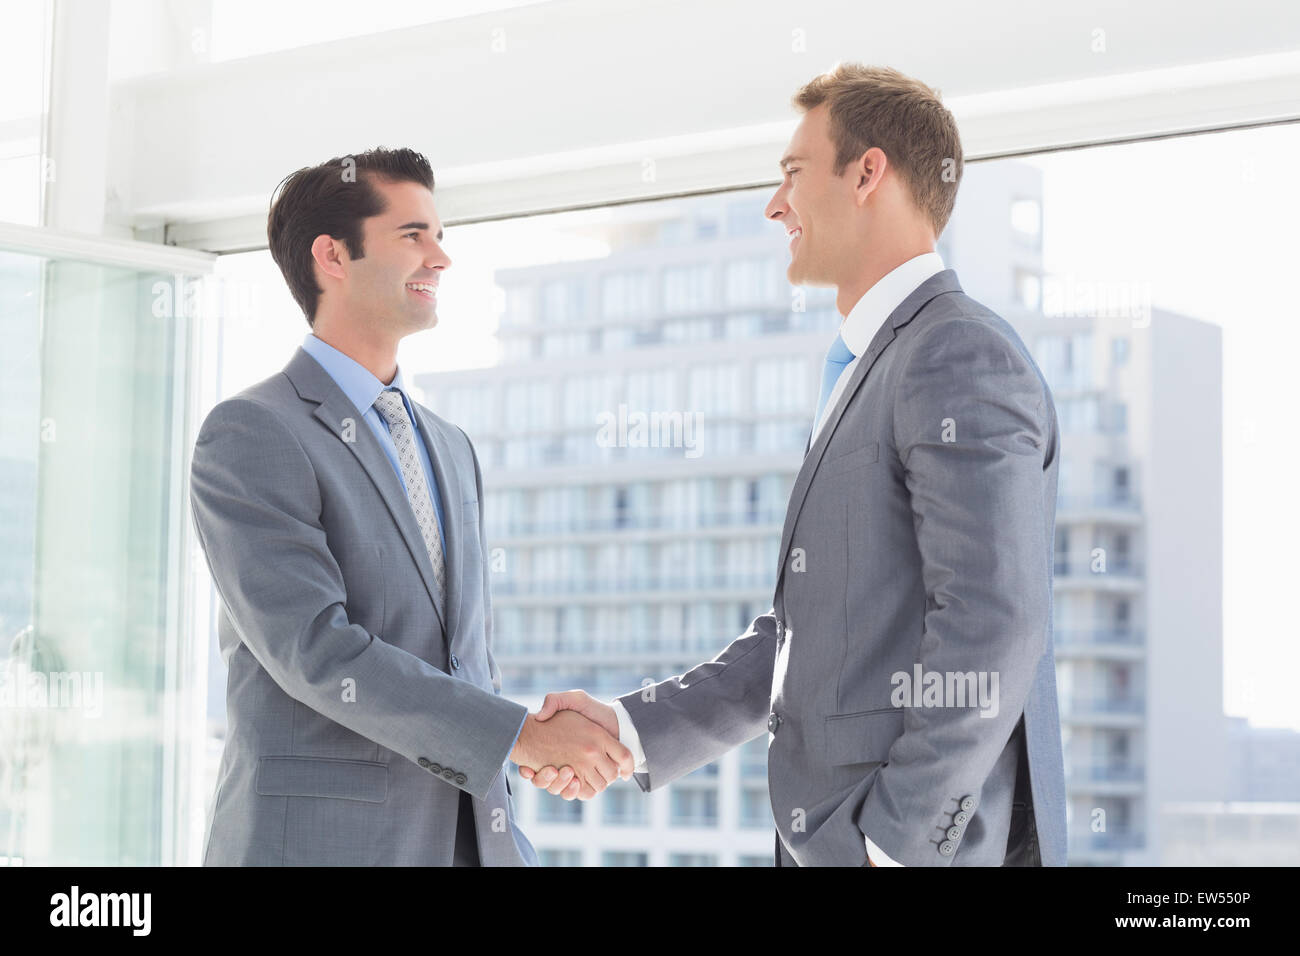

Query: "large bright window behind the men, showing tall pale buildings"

xmin=175 ymin=126 xmax=1300 ymax=865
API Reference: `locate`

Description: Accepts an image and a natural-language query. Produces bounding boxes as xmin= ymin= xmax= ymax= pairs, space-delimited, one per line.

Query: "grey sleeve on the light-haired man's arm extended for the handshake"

xmin=618 ymin=610 xmax=776 ymax=791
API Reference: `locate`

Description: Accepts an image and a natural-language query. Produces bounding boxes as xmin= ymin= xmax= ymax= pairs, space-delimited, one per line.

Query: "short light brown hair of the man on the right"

xmin=794 ymin=62 xmax=962 ymax=237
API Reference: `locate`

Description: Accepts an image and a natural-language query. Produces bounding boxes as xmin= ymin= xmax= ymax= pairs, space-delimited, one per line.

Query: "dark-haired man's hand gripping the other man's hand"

xmin=510 ymin=697 xmax=632 ymax=800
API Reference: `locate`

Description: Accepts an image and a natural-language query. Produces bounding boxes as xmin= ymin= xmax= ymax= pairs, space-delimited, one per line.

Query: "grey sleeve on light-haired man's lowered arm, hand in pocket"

xmin=858 ymin=319 xmax=1056 ymax=866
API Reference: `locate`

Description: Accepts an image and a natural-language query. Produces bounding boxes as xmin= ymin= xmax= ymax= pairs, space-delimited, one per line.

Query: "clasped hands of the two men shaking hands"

xmin=510 ymin=691 xmax=633 ymax=800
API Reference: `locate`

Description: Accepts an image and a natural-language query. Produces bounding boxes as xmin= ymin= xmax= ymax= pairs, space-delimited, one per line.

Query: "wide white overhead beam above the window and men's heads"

xmin=91 ymin=0 xmax=1300 ymax=243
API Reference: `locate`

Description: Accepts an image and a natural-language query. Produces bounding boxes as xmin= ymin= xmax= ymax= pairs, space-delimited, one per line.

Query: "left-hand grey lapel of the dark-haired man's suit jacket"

xmin=285 ymin=346 xmax=449 ymax=628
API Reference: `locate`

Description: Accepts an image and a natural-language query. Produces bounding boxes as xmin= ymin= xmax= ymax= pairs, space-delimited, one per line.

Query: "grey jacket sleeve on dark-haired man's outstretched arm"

xmin=190 ymin=398 xmax=527 ymax=800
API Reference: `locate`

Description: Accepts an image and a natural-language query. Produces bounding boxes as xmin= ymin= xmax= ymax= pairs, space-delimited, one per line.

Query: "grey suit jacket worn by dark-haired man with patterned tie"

xmin=190 ymin=349 xmax=537 ymax=866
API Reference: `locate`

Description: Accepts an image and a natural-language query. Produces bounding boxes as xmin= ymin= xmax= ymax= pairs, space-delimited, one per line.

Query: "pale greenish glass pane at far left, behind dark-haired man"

xmin=0 ymin=254 xmax=203 ymax=865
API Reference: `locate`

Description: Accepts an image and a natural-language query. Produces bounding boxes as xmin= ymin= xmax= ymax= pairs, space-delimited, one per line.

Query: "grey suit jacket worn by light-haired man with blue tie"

xmin=619 ymin=269 xmax=1066 ymax=866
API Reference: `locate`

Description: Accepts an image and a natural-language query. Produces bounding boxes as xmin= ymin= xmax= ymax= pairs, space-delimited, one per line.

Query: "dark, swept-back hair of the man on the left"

xmin=267 ymin=146 xmax=433 ymax=328
